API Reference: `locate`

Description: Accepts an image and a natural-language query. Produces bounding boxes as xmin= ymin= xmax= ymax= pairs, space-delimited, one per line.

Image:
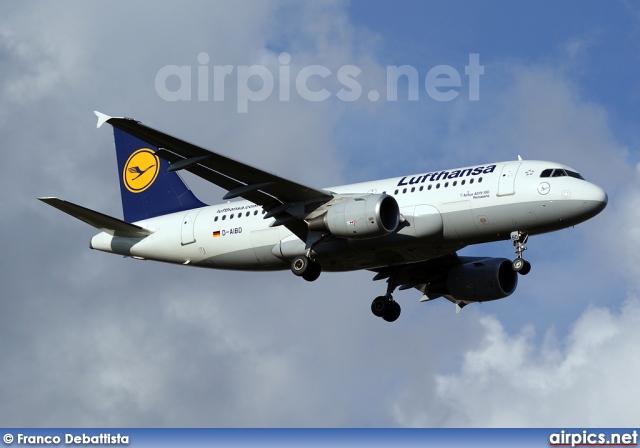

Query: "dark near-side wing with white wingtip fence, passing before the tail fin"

xmin=96 ymin=112 xmax=333 ymax=241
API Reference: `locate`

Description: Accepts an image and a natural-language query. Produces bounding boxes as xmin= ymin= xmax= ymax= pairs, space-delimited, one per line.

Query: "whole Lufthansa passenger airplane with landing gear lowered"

xmin=38 ymin=112 xmax=608 ymax=322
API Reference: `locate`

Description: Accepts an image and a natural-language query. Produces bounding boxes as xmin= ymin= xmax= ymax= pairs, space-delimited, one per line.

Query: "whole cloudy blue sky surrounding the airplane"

xmin=0 ymin=0 xmax=640 ymax=427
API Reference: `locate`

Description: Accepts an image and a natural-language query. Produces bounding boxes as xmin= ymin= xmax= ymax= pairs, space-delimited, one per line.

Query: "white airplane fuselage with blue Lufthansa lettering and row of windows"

xmin=91 ymin=160 xmax=607 ymax=271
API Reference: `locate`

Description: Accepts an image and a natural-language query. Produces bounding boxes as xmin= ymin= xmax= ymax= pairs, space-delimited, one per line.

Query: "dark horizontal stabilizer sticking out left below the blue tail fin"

xmin=38 ymin=198 xmax=153 ymax=238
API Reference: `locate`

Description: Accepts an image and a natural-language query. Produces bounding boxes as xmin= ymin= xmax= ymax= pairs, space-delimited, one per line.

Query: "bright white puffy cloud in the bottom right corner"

xmin=396 ymin=297 xmax=640 ymax=427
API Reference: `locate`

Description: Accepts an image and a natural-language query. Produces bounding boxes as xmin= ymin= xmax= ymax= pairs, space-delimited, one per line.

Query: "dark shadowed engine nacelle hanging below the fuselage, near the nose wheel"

xmin=445 ymin=258 xmax=518 ymax=302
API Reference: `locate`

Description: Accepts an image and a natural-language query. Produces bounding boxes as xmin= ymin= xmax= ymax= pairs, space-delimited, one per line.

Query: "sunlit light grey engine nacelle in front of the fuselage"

xmin=308 ymin=194 xmax=400 ymax=239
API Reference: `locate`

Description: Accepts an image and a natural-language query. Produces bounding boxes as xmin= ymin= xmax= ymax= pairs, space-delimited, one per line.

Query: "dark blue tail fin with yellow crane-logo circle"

xmin=109 ymin=123 xmax=206 ymax=222
